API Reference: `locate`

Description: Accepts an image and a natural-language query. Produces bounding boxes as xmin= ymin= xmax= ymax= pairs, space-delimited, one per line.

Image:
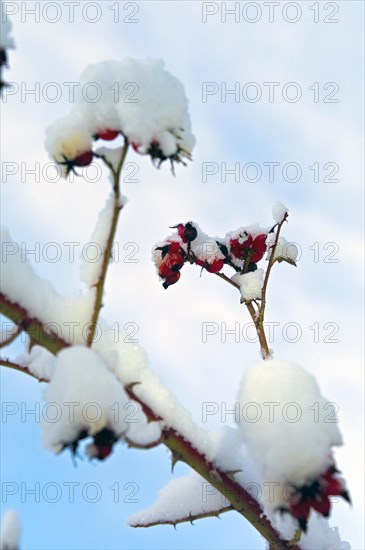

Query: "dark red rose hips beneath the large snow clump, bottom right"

xmin=280 ymin=466 xmax=351 ymax=532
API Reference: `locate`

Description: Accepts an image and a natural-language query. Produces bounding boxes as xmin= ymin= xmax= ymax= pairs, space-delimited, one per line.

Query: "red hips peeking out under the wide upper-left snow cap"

xmin=59 ymin=128 xmax=189 ymax=176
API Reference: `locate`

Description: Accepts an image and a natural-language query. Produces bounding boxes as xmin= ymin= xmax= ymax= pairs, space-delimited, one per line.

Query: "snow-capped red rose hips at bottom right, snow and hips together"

xmin=239 ymin=359 xmax=349 ymax=530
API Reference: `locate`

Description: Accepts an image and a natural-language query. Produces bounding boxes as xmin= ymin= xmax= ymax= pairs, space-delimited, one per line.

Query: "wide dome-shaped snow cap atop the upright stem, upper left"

xmin=46 ymin=58 xmax=195 ymax=171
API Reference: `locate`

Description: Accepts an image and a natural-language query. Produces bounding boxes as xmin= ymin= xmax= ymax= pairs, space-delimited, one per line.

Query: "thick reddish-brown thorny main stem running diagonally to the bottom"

xmin=0 ymin=294 xmax=300 ymax=550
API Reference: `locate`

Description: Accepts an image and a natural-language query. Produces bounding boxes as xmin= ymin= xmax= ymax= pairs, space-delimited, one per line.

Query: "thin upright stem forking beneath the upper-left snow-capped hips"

xmin=87 ymin=140 xmax=129 ymax=348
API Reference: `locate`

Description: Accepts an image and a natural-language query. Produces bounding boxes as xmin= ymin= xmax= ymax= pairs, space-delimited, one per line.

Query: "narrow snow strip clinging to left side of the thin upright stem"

xmin=80 ymin=193 xmax=114 ymax=287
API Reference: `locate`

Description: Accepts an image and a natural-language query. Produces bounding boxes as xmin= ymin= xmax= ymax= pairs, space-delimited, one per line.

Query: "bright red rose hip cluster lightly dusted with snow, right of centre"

xmin=154 ymin=222 xmax=268 ymax=288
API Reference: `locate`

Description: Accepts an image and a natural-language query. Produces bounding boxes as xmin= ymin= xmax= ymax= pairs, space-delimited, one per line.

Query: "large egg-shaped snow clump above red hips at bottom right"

xmin=239 ymin=359 xmax=342 ymax=506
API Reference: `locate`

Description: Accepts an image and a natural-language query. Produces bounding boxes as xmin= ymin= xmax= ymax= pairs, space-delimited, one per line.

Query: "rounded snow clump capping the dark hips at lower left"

xmin=42 ymin=346 xmax=130 ymax=452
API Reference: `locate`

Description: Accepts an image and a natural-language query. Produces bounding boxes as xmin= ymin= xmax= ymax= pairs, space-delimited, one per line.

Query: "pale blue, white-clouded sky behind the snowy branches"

xmin=1 ymin=0 xmax=364 ymax=550
